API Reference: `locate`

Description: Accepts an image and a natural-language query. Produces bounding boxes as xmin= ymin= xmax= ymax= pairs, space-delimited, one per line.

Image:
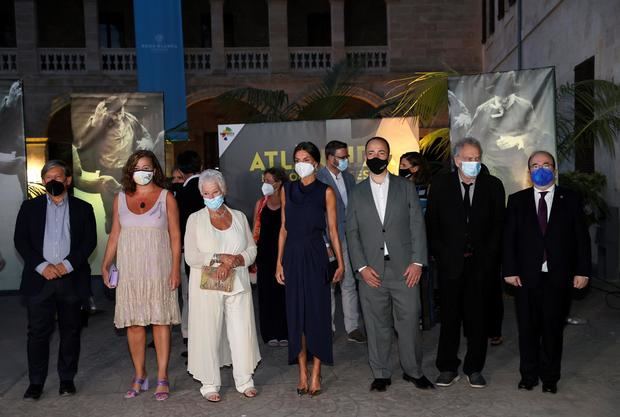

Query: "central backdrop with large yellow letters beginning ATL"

xmin=218 ymin=118 xmax=419 ymax=221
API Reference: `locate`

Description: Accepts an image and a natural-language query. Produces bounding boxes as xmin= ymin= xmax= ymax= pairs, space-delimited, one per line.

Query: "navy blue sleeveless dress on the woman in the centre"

xmin=282 ymin=180 xmax=334 ymax=365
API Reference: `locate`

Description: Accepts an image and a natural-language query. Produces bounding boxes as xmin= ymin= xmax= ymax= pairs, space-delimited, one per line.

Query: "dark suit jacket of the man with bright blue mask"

xmin=503 ymin=187 xmax=592 ymax=288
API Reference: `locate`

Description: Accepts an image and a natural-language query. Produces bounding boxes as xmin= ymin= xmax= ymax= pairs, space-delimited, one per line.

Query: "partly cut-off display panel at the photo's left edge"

xmin=0 ymin=80 xmax=26 ymax=291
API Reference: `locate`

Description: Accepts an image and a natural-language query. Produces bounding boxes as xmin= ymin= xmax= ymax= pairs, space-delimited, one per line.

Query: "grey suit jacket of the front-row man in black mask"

xmin=346 ymin=174 xmax=427 ymax=276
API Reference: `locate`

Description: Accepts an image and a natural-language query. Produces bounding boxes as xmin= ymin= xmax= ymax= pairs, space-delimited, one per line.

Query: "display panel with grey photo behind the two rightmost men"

xmin=448 ymin=68 xmax=556 ymax=195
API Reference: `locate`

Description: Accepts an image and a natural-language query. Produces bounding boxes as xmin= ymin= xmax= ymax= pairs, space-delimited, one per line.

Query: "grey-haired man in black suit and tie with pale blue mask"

xmin=426 ymin=138 xmax=505 ymax=388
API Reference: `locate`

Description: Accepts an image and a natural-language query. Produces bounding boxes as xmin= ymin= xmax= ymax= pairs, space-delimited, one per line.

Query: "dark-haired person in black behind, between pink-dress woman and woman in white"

xmin=175 ymin=150 xmax=205 ymax=357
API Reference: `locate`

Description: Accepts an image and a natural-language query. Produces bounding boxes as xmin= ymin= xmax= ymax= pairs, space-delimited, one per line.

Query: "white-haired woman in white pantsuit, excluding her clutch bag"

xmin=185 ymin=170 xmax=261 ymax=402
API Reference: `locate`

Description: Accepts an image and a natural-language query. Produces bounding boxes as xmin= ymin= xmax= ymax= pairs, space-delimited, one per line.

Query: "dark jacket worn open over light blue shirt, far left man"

xmin=13 ymin=195 xmax=97 ymax=299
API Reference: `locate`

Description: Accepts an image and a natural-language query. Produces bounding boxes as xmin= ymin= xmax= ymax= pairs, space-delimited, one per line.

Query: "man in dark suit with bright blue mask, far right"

xmin=503 ymin=151 xmax=592 ymax=394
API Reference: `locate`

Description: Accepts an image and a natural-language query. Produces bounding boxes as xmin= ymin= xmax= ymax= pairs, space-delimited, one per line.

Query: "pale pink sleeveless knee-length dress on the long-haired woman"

xmin=114 ymin=190 xmax=181 ymax=328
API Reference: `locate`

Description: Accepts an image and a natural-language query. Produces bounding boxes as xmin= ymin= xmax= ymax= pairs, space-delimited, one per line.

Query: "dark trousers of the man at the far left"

xmin=26 ymin=275 xmax=82 ymax=385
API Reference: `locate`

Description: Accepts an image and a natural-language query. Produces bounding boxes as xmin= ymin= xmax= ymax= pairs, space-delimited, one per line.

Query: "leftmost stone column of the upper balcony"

xmin=15 ymin=0 xmax=39 ymax=73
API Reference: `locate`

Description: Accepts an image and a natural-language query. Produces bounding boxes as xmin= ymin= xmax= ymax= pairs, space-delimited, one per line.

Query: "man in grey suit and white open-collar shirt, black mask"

xmin=346 ymin=137 xmax=434 ymax=391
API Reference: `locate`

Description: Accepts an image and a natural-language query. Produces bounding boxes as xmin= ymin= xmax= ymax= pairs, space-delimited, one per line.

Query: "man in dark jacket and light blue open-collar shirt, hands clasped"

xmin=14 ymin=160 xmax=97 ymax=400
